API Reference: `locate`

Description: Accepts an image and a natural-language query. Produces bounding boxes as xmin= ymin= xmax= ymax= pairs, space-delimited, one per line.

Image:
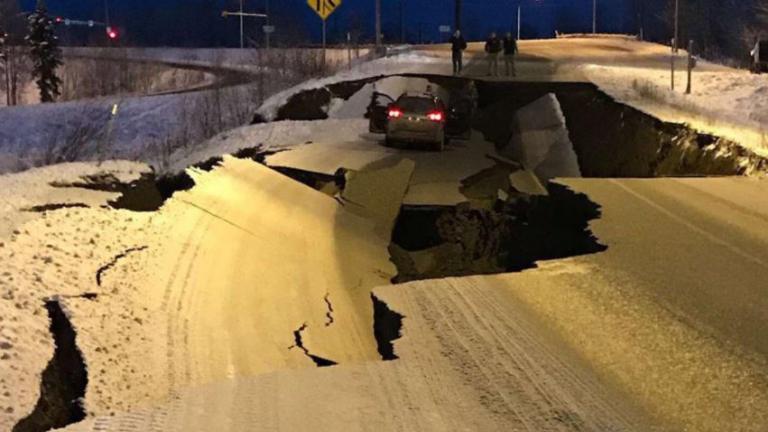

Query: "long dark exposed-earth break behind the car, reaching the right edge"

xmin=277 ymin=74 xmax=768 ymax=178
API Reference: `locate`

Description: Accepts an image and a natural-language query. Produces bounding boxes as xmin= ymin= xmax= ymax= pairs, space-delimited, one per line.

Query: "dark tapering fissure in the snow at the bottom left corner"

xmin=13 ymin=300 xmax=88 ymax=432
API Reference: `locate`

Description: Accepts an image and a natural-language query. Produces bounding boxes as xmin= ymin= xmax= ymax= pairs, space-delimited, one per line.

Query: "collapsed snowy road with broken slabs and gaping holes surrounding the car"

xmin=0 ymin=41 xmax=768 ymax=431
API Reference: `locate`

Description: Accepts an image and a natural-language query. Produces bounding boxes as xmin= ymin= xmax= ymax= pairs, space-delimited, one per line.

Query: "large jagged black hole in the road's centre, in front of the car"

xmin=390 ymin=183 xmax=607 ymax=283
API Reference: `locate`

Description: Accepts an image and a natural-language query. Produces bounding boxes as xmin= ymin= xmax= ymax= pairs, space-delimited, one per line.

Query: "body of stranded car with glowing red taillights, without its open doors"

xmin=386 ymin=93 xmax=447 ymax=151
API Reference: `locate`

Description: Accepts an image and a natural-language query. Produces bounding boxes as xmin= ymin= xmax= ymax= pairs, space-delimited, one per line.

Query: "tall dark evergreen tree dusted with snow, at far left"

xmin=26 ymin=0 xmax=62 ymax=102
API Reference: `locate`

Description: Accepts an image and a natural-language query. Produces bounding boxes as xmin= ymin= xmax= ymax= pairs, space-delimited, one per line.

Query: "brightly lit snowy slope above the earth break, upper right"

xmin=510 ymin=35 xmax=768 ymax=157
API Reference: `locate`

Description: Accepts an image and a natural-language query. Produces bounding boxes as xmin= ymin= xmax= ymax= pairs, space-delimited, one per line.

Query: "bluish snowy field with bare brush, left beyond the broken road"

xmin=0 ymin=49 xmax=388 ymax=173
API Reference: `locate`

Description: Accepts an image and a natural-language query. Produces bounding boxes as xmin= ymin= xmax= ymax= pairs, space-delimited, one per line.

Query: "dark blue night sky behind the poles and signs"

xmin=21 ymin=0 xmax=634 ymax=46
